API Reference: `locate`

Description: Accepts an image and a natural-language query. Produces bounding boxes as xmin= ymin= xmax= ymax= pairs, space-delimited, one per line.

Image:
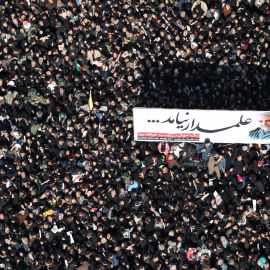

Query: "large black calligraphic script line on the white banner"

xmin=147 ymin=112 xmax=252 ymax=133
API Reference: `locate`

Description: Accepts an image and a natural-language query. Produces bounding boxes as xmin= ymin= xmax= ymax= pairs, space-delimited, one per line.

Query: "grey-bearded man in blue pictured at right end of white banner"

xmin=249 ymin=112 xmax=270 ymax=140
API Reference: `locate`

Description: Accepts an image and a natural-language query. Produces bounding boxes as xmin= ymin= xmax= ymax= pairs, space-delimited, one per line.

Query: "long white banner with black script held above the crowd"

xmin=133 ymin=108 xmax=270 ymax=144
